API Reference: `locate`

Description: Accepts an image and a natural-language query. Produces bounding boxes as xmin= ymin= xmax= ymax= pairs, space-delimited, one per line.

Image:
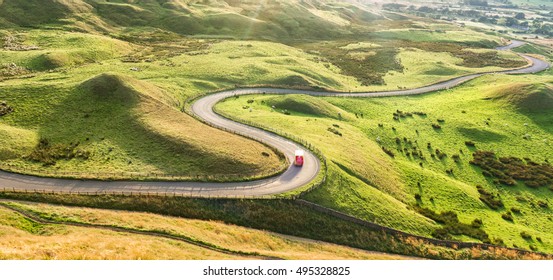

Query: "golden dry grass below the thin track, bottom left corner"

xmin=0 ymin=209 xmax=241 ymax=260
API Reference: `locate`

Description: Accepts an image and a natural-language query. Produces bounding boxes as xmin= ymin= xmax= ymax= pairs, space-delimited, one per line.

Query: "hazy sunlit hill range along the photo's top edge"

xmin=0 ymin=0 xmax=382 ymax=40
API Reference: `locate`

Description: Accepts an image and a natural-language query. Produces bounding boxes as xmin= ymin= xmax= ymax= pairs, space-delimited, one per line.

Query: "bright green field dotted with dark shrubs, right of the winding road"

xmin=218 ymin=71 xmax=553 ymax=252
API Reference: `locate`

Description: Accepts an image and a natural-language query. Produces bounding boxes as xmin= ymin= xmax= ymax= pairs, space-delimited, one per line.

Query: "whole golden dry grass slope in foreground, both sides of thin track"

xmin=0 ymin=202 xmax=406 ymax=260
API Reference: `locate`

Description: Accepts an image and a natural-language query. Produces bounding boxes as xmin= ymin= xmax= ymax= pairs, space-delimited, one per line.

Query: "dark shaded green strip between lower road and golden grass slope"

xmin=0 ymin=193 xmax=542 ymax=259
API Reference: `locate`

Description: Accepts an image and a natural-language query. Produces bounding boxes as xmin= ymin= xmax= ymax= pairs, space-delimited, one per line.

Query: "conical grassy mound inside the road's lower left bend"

xmin=1 ymin=74 xmax=282 ymax=179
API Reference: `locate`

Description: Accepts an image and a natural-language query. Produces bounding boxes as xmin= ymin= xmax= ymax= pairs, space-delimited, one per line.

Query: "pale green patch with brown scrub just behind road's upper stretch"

xmin=298 ymin=37 xmax=527 ymax=91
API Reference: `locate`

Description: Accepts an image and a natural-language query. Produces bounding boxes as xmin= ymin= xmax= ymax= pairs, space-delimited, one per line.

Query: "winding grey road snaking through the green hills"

xmin=0 ymin=41 xmax=550 ymax=197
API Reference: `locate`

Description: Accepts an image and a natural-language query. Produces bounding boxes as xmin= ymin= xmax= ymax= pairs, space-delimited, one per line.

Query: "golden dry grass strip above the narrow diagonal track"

xmin=2 ymin=203 xmax=412 ymax=259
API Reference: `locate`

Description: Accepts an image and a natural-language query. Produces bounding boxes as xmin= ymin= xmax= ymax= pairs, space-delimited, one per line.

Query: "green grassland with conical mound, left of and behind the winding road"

xmin=0 ymin=27 xmax=516 ymax=180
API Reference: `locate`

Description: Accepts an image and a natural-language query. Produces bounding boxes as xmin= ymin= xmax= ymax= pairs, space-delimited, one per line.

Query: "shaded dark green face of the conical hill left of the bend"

xmin=34 ymin=76 xmax=268 ymax=176
